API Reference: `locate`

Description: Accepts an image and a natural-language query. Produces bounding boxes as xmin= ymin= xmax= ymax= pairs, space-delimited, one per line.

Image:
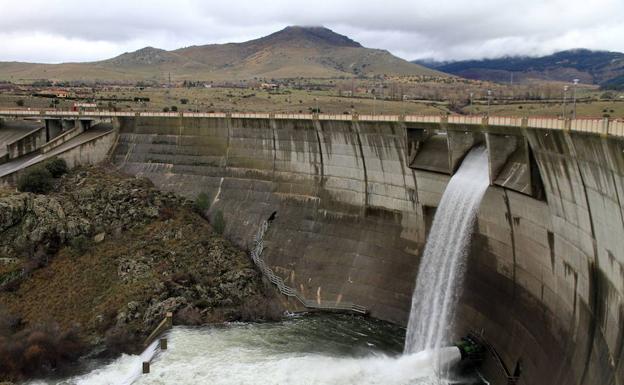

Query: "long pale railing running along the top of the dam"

xmin=0 ymin=109 xmax=624 ymax=136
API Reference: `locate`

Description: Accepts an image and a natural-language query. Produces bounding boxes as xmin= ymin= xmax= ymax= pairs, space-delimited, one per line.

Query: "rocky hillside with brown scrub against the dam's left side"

xmin=0 ymin=167 xmax=281 ymax=368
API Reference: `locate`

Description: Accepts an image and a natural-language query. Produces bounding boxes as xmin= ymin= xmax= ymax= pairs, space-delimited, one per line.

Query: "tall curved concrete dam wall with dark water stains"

xmin=114 ymin=116 xmax=624 ymax=385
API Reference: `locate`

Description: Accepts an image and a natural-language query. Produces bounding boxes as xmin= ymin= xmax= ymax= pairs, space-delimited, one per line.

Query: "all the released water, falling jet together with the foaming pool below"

xmin=31 ymin=147 xmax=489 ymax=385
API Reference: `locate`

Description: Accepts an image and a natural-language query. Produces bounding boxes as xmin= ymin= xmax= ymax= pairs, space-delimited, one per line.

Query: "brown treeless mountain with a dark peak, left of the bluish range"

xmin=0 ymin=26 xmax=448 ymax=81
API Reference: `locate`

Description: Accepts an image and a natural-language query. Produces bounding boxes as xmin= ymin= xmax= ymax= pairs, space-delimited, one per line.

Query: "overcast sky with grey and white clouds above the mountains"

xmin=0 ymin=0 xmax=624 ymax=63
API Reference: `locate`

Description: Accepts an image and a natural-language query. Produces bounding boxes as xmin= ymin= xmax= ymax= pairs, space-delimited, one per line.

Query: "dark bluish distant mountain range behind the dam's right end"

xmin=415 ymin=49 xmax=624 ymax=87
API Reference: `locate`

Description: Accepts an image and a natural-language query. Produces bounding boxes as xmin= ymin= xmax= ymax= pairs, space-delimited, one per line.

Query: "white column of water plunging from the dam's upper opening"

xmin=405 ymin=146 xmax=489 ymax=353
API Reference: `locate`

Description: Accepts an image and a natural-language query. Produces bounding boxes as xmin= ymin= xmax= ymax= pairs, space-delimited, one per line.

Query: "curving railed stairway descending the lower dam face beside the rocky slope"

xmin=251 ymin=221 xmax=368 ymax=314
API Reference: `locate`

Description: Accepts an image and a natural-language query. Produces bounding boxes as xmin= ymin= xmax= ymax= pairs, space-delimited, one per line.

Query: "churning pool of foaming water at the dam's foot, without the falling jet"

xmin=30 ymin=316 xmax=468 ymax=385
